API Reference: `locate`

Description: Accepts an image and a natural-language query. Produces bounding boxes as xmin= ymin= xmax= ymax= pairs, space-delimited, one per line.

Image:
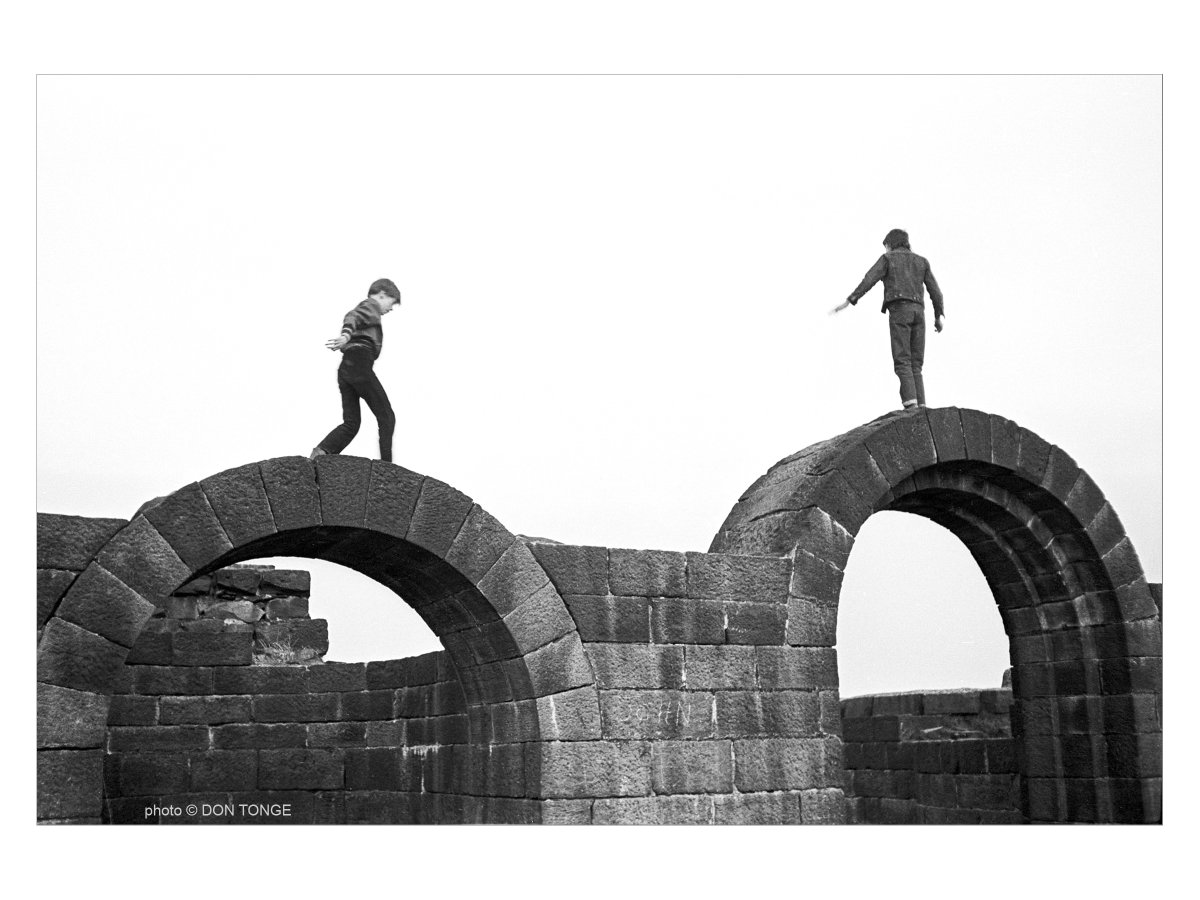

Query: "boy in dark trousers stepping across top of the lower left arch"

xmin=308 ymin=278 xmax=400 ymax=462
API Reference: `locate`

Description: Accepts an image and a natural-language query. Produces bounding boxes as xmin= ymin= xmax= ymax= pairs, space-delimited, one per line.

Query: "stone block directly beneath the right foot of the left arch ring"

xmin=526 ymin=740 xmax=650 ymax=799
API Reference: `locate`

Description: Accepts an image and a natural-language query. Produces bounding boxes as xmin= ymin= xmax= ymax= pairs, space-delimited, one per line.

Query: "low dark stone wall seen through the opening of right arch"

xmin=841 ymin=689 xmax=1022 ymax=824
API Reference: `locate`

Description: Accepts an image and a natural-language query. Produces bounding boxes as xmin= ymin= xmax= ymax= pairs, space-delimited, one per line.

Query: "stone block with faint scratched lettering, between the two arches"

xmin=600 ymin=690 xmax=721 ymax=740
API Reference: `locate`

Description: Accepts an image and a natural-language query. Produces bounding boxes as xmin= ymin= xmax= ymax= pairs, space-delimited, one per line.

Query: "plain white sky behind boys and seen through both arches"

xmin=37 ymin=76 xmax=1163 ymax=696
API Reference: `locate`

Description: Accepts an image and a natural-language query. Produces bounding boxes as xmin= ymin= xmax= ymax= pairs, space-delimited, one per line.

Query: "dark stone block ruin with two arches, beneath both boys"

xmin=37 ymin=408 xmax=1162 ymax=824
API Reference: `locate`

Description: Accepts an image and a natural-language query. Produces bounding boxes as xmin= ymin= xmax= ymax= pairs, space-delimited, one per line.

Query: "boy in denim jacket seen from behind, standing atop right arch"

xmin=829 ymin=228 xmax=946 ymax=409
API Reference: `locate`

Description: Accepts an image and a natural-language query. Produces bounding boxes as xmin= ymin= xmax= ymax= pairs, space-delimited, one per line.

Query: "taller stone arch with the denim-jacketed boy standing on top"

xmin=710 ymin=408 xmax=1162 ymax=822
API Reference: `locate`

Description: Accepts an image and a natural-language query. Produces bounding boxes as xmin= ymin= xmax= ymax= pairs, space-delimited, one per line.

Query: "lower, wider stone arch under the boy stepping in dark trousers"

xmin=37 ymin=456 xmax=600 ymax=825
